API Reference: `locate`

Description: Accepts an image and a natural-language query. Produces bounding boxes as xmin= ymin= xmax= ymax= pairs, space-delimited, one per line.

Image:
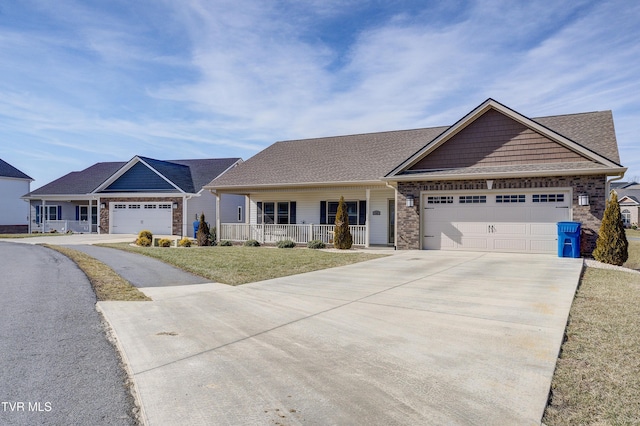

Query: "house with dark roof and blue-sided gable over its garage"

xmin=22 ymin=156 xmax=244 ymax=236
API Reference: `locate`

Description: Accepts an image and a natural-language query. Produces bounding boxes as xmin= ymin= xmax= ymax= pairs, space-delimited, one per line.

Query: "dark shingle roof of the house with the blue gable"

xmin=27 ymin=156 xmax=240 ymax=196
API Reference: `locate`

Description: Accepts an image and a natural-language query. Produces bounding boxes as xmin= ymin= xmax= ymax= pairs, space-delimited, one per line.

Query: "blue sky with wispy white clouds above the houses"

xmin=0 ymin=0 xmax=640 ymax=189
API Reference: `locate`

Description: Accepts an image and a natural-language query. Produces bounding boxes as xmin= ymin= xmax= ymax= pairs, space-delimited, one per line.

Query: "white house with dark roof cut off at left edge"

xmin=0 ymin=160 xmax=33 ymax=234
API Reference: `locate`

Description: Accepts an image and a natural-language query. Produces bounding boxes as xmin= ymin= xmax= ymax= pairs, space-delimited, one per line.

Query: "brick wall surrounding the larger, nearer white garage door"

xmin=396 ymin=175 xmax=608 ymax=256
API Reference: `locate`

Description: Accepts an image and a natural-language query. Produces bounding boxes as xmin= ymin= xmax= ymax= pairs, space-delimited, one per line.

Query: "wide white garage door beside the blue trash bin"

xmin=422 ymin=190 xmax=571 ymax=253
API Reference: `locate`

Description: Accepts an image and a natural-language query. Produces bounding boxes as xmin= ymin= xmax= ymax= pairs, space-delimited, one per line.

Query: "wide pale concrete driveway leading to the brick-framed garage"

xmin=99 ymin=251 xmax=582 ymax=425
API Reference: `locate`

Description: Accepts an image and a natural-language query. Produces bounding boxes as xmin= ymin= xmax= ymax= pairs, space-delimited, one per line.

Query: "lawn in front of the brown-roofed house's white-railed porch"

xmin=101 ymin=243 xmax=385 ymax=285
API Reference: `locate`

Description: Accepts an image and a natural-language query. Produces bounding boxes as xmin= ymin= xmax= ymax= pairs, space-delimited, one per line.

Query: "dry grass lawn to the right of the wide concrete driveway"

xmin=543 ymin=240 xmax=640 ymax=426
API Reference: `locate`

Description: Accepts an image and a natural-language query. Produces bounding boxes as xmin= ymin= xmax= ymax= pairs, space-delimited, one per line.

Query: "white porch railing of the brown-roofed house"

xmin=218 ymin=223 xmax=367 ymax=246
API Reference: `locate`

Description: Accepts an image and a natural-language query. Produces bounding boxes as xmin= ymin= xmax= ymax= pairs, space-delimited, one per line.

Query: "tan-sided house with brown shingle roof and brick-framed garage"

xmin=205 ymin=99 xmax=626 ymax=253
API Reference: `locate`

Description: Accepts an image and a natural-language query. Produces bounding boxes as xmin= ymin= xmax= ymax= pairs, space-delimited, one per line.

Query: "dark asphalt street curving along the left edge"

xmin=0 ymin=242 xmax=136 ymax=425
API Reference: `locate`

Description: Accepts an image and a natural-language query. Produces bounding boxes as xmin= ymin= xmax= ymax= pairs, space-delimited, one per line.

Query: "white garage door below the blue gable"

xmin=109 ymin=203 xmax=172 ymax=235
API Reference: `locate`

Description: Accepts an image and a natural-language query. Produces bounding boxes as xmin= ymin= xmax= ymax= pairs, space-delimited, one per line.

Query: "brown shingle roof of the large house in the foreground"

xmin=207 ymin=111 xmax=620 ymax=189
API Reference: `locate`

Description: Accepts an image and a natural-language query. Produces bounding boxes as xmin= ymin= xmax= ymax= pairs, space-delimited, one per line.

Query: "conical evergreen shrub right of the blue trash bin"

xmin=593 ymin=191 xmax=629 ymax=266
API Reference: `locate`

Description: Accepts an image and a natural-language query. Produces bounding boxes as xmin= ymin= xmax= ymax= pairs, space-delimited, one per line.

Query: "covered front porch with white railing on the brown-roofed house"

xmin=216 ymin=185 xmax=396 ymax=247
